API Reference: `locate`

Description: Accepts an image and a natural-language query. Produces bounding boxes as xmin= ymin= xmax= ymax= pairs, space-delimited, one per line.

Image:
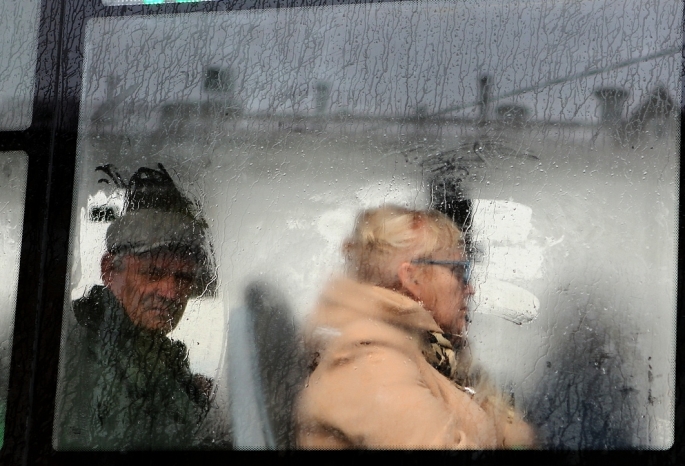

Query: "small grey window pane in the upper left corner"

xmin=0 ymin=0 xmax=40 ymax=130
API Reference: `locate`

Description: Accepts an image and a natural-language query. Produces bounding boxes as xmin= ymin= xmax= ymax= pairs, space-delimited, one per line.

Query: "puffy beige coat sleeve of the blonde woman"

xmin=298 ymin=345 xmax=495 ymax=448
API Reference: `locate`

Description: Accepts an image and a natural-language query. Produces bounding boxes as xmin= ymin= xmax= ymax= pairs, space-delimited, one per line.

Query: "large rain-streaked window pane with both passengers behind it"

xmin=53 ymin=0 xmax=682 ymax=450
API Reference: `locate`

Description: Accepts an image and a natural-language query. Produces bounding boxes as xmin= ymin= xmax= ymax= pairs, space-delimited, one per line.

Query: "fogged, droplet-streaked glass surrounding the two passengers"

xmin=55 ymin=0 xmax=682 ymax=450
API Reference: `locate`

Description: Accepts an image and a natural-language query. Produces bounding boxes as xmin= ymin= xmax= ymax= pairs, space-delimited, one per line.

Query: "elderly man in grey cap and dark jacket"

xmin=55 ymin=164 xmax=220 ymax=450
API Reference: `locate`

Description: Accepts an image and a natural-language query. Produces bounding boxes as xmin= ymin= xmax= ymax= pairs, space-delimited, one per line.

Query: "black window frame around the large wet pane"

xmin=0 ymin=0 xmax=685 ymax=465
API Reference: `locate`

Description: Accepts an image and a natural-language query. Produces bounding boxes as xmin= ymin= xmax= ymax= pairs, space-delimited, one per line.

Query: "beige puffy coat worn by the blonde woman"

xmin=296 ymin=279 xmax=534 ymax=449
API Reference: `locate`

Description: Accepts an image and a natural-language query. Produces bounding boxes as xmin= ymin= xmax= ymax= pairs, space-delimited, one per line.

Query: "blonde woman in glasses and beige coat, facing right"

xmin=296 ymin=206 xmax=534 ymax=449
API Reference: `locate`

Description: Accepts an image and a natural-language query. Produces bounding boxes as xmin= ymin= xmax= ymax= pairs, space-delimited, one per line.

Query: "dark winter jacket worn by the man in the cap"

xmin=55 ymin=286 xmax=210 ymax=450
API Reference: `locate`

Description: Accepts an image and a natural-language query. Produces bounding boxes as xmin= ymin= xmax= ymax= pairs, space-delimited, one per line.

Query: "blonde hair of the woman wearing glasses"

xmin=343 ymin=205 xmax=464 ymax=289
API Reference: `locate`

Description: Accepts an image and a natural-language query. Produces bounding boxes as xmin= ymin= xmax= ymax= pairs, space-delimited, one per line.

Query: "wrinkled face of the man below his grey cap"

xmin=102 ymin=251 xmax=197 ymax=333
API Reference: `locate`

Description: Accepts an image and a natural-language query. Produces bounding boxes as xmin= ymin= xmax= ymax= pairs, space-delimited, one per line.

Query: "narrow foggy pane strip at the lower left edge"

xmin=0 ymin=152 xmax=28 ymax=446
